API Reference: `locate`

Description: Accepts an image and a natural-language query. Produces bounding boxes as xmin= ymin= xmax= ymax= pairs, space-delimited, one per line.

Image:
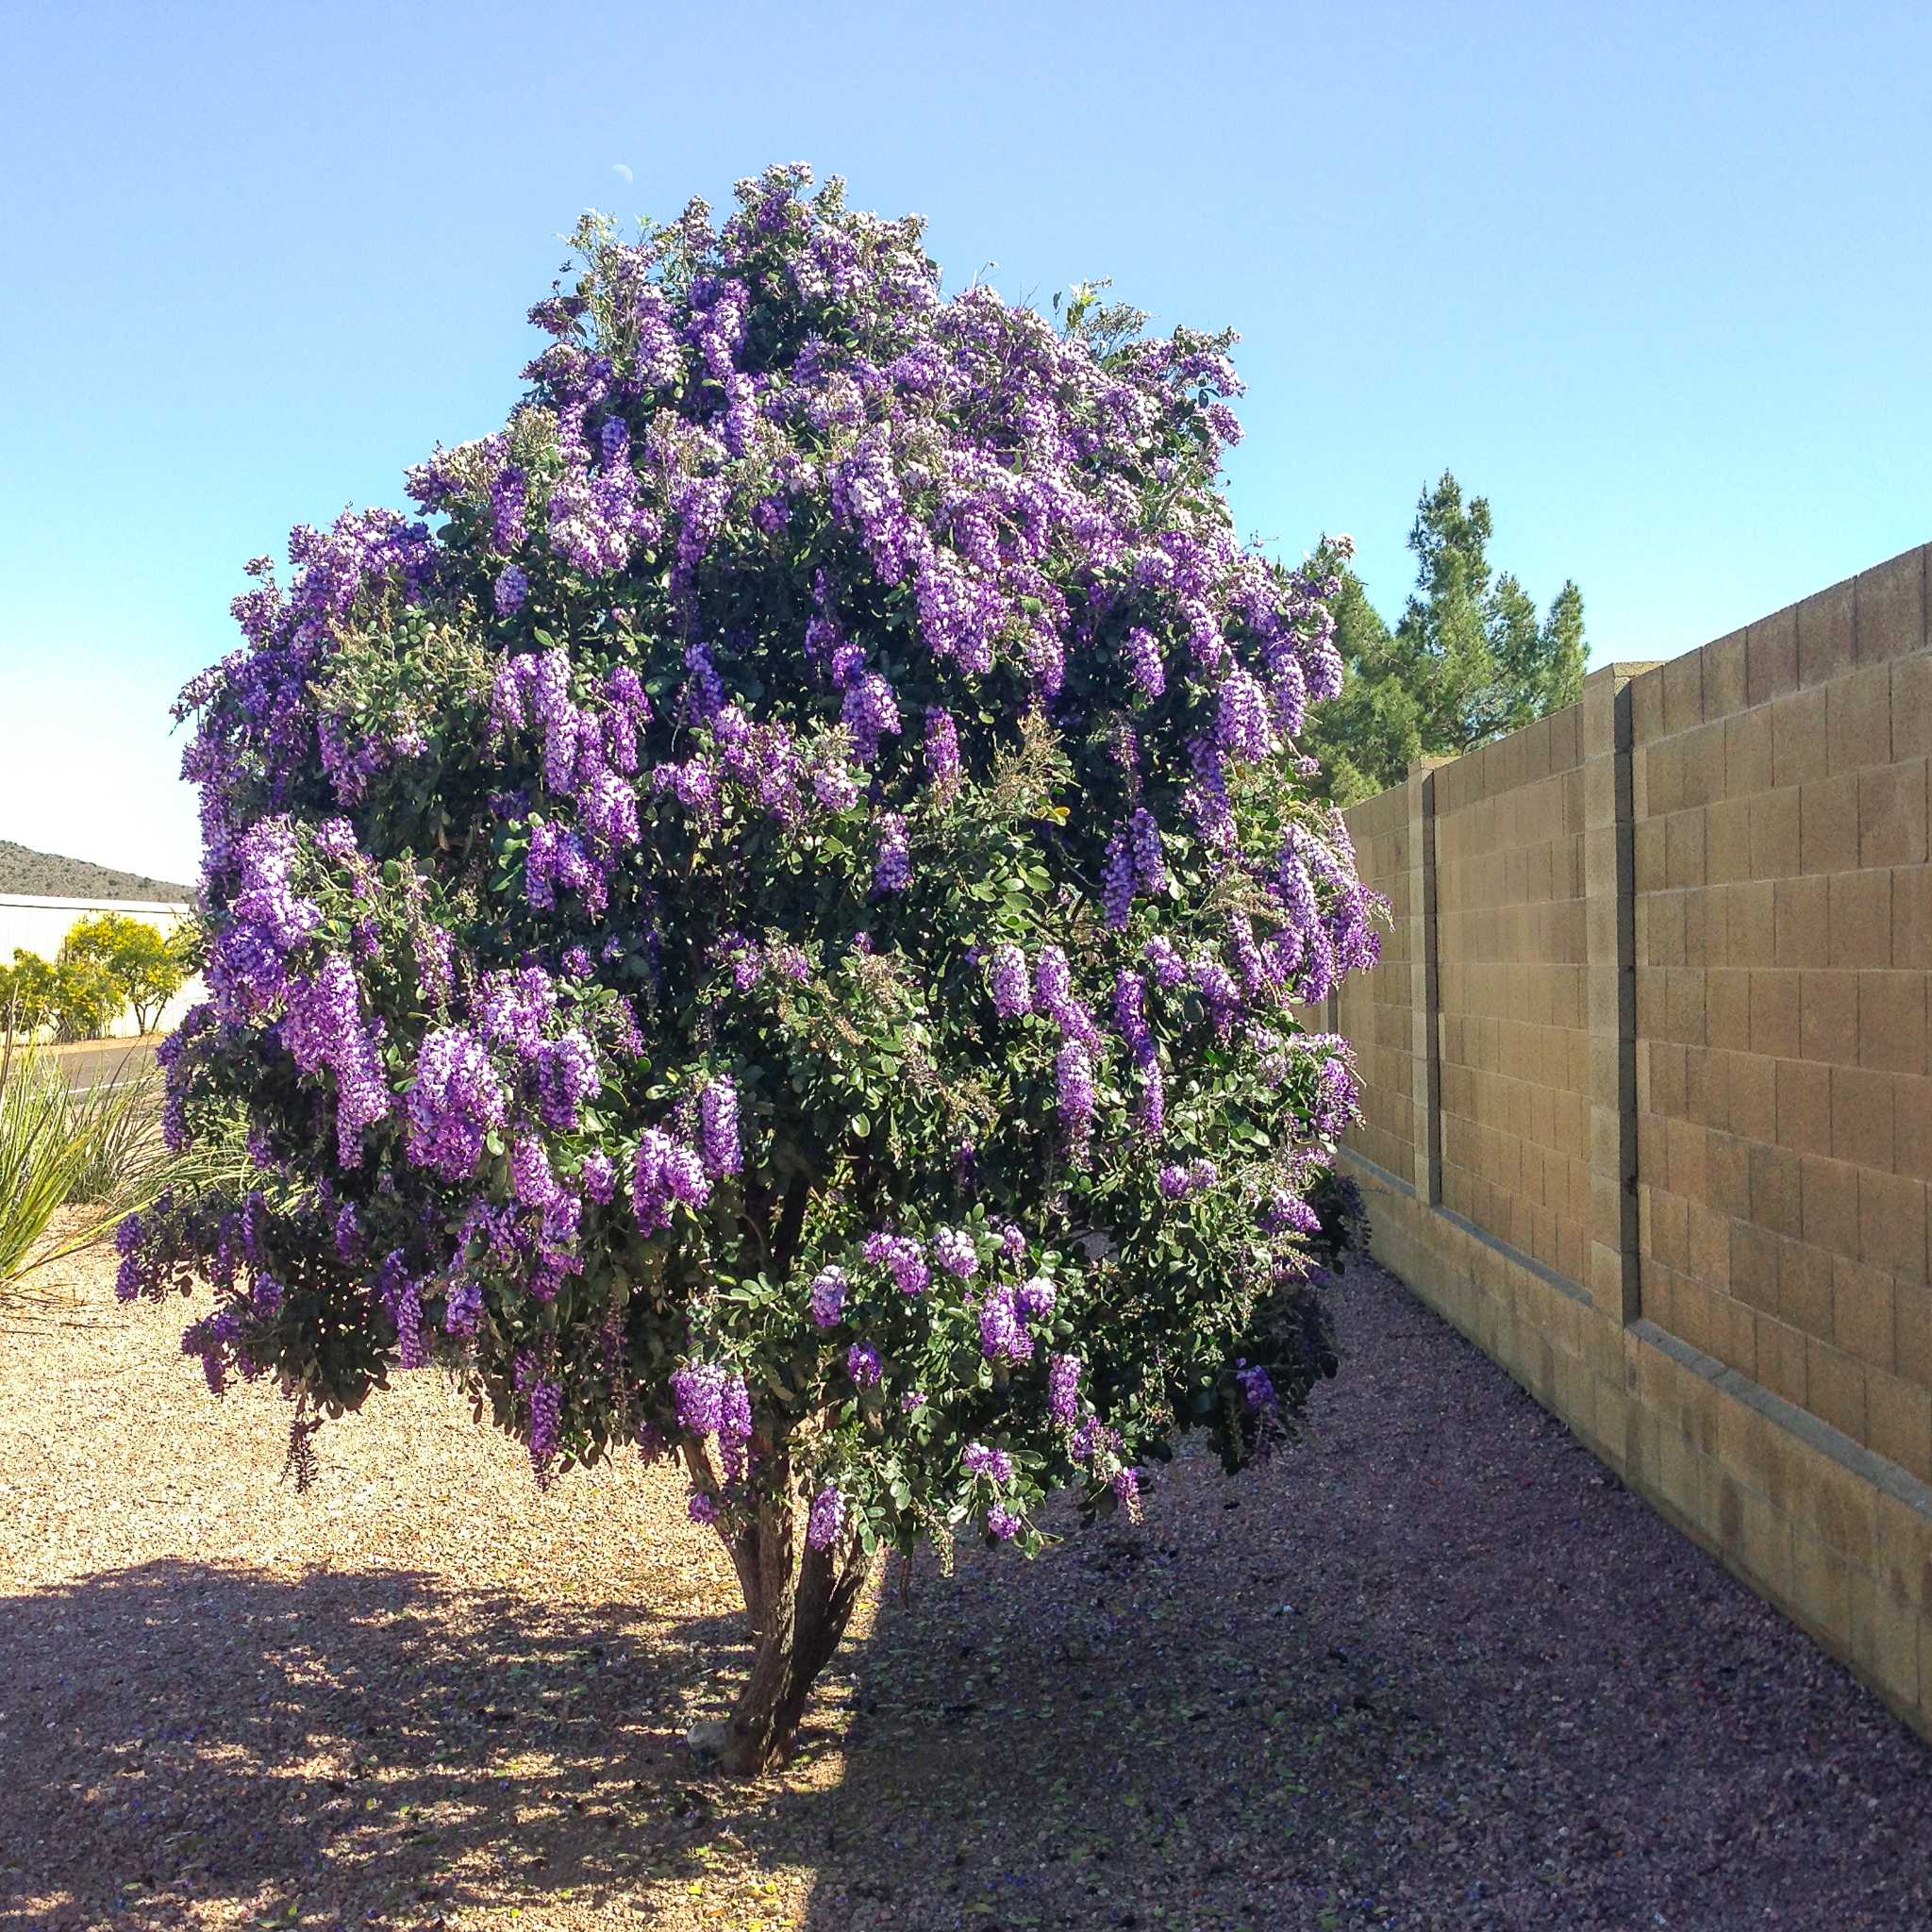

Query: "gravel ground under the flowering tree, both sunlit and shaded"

xmin=0 ymin=1256 xmax=1932 ymax=1932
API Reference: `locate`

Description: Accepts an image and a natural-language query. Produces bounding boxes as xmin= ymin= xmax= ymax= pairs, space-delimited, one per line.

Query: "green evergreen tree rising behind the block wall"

xmin=1306 ymin=472 xmax=1588 ymax=804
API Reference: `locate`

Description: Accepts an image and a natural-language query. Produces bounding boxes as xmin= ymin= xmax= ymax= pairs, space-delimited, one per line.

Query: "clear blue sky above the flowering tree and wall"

xmin=0 ymin=0 xmax=1932 ymax=879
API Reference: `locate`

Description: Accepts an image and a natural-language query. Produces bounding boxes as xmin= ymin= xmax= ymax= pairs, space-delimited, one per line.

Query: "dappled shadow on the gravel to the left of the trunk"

xmin=0 ymin=1561 xmax=838 ymax=1932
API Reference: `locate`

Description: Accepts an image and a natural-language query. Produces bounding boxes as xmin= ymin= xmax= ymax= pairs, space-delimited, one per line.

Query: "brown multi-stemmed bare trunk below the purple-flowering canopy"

xmin=693 ymin=1501 xmax=870 ymax=1777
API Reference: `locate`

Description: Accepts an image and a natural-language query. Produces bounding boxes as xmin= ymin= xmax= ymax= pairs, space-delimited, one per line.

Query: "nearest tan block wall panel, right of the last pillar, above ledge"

xmin=1631 ymin=553 xmax=1932 ymax=1482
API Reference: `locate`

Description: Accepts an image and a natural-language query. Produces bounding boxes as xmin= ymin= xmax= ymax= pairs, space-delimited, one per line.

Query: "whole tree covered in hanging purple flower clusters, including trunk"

xmin=120 ymin=166 xmax=1375 ymax=1770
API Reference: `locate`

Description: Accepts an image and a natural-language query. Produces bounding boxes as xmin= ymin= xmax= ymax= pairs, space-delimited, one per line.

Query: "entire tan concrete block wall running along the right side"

xmin=1331 ymin=551 xmax=1932 ymax=1735
